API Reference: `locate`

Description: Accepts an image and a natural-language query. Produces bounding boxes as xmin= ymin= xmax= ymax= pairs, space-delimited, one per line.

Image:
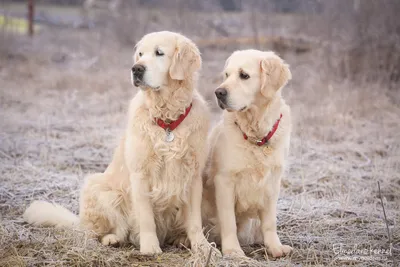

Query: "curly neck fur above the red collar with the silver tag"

xmin=145 ymin=80 xmax=193 ymax=121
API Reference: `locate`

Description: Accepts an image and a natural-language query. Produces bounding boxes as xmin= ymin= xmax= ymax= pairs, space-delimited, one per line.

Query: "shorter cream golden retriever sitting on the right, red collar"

xmin=203 ymin=50 xmax=292 ymax=257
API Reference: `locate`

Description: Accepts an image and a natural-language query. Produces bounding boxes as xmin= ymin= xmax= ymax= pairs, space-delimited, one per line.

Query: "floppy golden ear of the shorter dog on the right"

xmin=260 ymin=54 xmax=292 ymax=98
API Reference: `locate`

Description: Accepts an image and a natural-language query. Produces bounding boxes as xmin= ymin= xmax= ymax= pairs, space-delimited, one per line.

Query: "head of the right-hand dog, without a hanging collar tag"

xmin=215 ymin=50 xmax=292 ymax=111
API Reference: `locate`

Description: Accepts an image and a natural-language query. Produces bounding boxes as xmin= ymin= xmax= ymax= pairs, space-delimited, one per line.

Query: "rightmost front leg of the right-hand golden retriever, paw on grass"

xmin=259 ymin=174 xmax=292 ymax=258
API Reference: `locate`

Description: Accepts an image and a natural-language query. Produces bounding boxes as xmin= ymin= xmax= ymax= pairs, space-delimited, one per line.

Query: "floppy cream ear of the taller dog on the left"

xmin=169 ymin=37 xmax=201 ymax=81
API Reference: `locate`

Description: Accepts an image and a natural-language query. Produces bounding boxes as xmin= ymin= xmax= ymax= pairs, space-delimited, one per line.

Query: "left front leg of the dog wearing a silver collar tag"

xmin=131 ymin=174 xmax=162 ymax=254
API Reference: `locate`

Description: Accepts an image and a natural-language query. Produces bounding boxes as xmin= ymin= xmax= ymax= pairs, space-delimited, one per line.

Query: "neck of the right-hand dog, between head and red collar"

xmin=234 ymin=93 xmax=282 ymax=139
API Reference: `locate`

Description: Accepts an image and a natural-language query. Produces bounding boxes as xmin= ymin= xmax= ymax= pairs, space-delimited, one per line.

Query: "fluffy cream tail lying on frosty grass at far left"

xmin=23 ymin=200 xmax=79 ymax=228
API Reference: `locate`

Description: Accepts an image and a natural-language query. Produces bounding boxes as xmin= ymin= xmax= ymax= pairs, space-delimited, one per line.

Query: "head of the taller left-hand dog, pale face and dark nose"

xmin=131 ymin=31 xmax=201 ymax=91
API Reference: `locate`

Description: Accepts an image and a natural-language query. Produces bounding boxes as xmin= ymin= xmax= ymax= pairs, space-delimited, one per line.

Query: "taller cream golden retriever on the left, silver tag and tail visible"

xmin=24 ymin=32 xmax=209 ymax=254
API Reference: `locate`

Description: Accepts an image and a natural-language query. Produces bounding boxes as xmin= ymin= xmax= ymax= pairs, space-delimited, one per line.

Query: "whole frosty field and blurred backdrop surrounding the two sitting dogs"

xmin=0 ymin=0 xmax=400 ymax=267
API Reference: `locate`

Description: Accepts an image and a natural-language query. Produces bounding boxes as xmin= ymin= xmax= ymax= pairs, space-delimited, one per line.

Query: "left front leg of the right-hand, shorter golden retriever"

xmin=215 ymin=175 xmax=244 ymax=255
